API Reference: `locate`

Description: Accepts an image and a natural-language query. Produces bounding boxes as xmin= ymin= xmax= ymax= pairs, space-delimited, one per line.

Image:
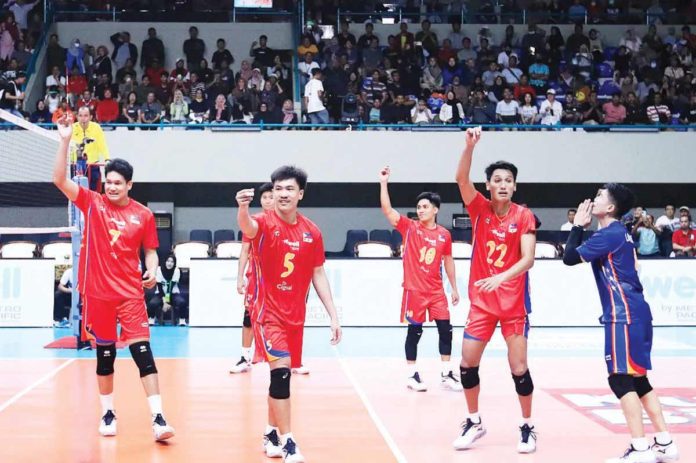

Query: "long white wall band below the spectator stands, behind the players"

xmin=98 ymin=130 xmax=696 ymax=183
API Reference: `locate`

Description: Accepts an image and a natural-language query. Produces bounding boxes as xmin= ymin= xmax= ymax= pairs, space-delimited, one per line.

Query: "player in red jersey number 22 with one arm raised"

xmin=454 ymin=127 xmax=536 ymax=453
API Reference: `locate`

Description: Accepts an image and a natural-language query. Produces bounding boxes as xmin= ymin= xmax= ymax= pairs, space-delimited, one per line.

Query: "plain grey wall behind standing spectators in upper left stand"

xmin=56 ymin=22 xmax=293 ymax=74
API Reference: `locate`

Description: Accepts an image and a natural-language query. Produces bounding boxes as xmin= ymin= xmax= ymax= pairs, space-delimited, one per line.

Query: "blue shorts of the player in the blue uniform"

xmin=604 ymin=322 xmax=652 ymax=376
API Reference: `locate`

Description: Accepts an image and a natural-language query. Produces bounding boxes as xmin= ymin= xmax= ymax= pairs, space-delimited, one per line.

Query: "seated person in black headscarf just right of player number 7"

xmin=147 ymin=254 xmax=188 ymax=326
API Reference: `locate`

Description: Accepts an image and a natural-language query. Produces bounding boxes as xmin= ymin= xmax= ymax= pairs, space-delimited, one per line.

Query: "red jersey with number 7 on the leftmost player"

xmin=75 ymin=187 xmax=159 ymax=300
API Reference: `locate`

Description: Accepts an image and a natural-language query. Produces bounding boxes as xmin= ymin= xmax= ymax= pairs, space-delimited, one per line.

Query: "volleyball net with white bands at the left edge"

xmin=0 ymin=109 xmax=81 ymax=235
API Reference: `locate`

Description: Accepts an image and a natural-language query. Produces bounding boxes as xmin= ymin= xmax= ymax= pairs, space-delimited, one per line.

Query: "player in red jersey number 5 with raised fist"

xmin=237 ymin=166 xmax=341 ymax=463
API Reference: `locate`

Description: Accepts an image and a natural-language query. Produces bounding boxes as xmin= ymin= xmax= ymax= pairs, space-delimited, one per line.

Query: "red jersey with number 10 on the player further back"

xmin=396 ymin=215 xmax=452 ymax=293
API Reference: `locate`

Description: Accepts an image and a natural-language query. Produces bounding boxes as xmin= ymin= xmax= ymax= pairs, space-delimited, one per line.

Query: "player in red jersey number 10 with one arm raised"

xmin=379 ymin=167 xmax=462 ymax=391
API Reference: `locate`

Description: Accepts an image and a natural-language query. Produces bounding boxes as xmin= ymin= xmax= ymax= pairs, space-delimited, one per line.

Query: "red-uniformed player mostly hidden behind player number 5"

xmin=230 ymin=183 xmax=273 ymax=373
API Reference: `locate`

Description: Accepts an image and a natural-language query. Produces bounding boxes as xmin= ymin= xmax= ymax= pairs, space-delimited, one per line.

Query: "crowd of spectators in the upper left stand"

xmin=7 ymin=26 xmax=298 ymax=129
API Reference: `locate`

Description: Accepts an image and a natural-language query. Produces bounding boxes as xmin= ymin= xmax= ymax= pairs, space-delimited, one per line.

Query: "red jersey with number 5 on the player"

xmin=251 ymin=212 xmax=325 ymax=326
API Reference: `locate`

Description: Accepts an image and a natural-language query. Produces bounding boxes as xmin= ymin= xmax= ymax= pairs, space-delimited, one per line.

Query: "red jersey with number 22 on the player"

xmin=466 ymin=192 xmax=536 ymax=313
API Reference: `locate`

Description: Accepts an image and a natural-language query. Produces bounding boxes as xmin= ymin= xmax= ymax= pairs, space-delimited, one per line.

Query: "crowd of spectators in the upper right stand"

xmin=297 ymin=20 xmax=696 ymax=125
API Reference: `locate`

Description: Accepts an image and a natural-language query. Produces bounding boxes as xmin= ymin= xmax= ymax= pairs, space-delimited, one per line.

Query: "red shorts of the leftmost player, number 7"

xmin=82 ymin=296 xmax=150 ymax=344
